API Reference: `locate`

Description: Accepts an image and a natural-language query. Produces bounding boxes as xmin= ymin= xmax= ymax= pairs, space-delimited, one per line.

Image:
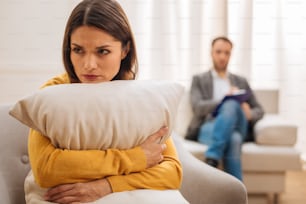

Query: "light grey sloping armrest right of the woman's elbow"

xmin=173 ymin=134 xmax=247 ymax=204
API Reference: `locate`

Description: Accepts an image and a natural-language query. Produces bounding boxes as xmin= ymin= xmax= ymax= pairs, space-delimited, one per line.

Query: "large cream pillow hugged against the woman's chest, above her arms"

xmin=10 ymin=80 xmax=183 ymax=149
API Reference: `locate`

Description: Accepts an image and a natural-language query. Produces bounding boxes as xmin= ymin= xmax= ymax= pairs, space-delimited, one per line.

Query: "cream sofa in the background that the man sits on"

xmin=175 ymin=89 xmax=302 ymax=204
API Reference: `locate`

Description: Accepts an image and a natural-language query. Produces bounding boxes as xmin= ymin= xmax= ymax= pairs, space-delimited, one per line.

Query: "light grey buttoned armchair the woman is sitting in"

xmin=0 ymin=104 xmax=247 ymax=204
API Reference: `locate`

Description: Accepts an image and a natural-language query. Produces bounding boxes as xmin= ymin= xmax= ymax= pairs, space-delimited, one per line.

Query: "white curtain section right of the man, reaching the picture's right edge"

xmin=228 ymin=0 xmax=306 ymax=160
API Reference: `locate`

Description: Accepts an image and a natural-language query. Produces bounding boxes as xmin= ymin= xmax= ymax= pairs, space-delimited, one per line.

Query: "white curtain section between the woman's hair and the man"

xmin=120 ymin=0 xmax=227 ymax=84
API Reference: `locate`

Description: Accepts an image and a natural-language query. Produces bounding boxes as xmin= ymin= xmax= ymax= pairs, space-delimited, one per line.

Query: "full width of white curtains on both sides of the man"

xmin=120 ymin=0 xmax=306 ymax=159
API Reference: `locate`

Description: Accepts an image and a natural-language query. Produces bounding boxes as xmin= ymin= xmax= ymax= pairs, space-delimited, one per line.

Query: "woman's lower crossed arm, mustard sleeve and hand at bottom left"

xmin=45 ymin=138 xmax=182 ymax=203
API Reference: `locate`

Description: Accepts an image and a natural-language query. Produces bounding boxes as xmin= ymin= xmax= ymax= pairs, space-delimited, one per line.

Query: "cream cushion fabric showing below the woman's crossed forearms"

xmin=25 ymin=172 xmax=188 ymax=204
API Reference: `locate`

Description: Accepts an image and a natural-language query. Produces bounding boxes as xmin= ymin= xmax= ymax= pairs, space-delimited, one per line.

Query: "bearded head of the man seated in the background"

xmin=211 ymin=37 xmax=233 ymax=72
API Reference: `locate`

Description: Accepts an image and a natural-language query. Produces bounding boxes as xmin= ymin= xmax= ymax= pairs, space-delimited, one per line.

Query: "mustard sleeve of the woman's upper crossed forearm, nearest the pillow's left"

xmin=28 ymin=129 xmax=147 ymax=187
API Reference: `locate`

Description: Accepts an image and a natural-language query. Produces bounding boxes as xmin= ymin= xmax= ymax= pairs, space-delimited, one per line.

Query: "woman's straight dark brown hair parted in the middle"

xmin=62 ymin=0 xmax=138 ymax=83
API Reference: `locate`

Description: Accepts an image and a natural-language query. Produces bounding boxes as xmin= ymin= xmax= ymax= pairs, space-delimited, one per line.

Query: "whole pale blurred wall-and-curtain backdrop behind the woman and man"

xmin=0 ymin=0 xmax=306 ymax=163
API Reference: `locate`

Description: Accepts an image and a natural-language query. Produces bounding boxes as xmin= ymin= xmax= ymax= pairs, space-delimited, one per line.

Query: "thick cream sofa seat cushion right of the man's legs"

xmin=242 ymin=142 xmax=301 ymax=172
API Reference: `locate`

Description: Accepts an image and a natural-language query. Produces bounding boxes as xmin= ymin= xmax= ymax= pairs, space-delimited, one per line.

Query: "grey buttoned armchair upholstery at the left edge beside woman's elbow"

xmin=0 ymin=105 xmax=30 ymax=204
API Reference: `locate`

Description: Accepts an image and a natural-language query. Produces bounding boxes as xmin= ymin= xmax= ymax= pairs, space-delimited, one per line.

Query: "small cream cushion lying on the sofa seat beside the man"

xmin=255 ymin=114 xmax=297 ymax=146
